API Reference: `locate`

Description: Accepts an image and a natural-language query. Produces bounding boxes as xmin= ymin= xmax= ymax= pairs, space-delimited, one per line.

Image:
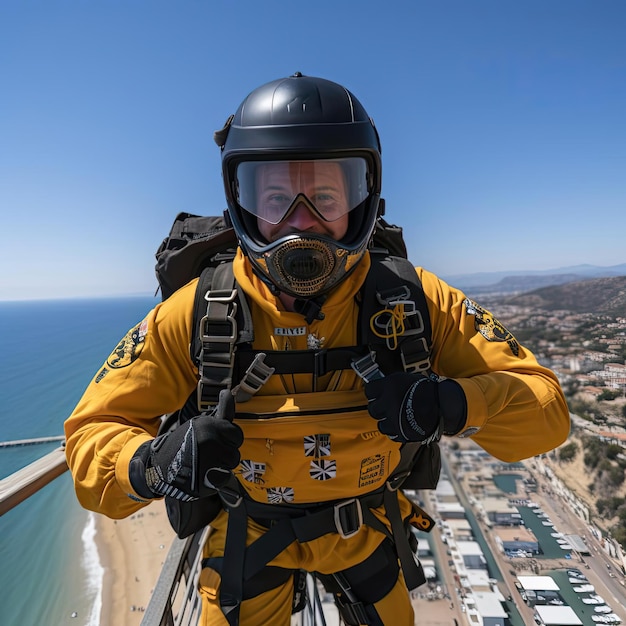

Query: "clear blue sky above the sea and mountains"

xmin=0 ymin=0 xmax=626 ymax=300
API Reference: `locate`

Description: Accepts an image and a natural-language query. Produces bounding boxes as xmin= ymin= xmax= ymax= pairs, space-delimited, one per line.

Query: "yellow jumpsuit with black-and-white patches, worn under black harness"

xmin=65 ymin=246 xmax=569 ymax=626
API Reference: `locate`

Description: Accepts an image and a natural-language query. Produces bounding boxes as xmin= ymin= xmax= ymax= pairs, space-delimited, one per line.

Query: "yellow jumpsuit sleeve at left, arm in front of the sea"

xmin=65 ymin=281 xmax=198 ymax=519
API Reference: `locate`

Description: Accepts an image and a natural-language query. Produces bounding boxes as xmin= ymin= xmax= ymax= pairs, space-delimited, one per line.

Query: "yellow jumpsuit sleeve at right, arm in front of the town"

xmin=417 ymin=268 xmax=570 ymax=462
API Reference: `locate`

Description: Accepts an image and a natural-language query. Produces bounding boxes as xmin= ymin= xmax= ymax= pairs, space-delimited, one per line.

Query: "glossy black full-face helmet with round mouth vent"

xmin=215 ymin=72 xmax=381 ymax=298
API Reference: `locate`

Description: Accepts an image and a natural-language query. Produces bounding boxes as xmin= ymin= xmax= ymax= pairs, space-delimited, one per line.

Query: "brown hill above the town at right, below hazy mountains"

xmin=505 ymin=276 xmax=626 ymax=316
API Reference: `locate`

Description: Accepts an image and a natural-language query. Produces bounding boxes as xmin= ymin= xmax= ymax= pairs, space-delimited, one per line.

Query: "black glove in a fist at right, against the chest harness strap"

xmin=365 ymin=372 xmax=467 ymax=443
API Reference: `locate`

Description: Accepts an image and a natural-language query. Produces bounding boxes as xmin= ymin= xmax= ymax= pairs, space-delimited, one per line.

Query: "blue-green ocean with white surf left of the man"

xmin=0 ymin=297 xmax=157 ymax=626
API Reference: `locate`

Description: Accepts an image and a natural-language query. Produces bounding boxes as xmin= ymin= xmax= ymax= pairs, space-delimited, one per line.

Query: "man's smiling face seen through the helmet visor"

xmin=256 ymin=161 xmax=350 ymax=241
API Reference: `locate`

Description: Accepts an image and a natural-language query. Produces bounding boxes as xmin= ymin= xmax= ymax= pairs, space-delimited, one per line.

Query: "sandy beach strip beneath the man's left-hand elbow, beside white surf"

xmin=96 ymin=501 xmax=175 ymax=626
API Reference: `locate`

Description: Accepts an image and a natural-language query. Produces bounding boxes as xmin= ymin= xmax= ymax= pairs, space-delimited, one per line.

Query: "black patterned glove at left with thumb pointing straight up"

xmin=129 ymin=390 xmax=243 ymax=500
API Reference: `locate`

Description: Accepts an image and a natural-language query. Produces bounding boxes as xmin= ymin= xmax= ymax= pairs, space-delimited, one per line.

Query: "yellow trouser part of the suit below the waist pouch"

xmin=199 ymin=513 xmax=414 ymax=626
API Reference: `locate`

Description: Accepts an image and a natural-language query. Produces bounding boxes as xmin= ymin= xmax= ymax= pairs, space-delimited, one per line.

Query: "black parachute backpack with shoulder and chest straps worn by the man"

xmin=155 ymin=213 xmax=441 ymax=538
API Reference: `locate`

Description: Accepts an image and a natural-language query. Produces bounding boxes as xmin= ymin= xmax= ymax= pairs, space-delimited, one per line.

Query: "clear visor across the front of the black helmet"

xmin=235 ymin=157 xmax=370 ymax=224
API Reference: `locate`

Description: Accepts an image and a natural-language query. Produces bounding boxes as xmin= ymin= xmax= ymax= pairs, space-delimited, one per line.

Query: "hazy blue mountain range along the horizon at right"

xmin=442 ymin=263 xmax=626 ymax=295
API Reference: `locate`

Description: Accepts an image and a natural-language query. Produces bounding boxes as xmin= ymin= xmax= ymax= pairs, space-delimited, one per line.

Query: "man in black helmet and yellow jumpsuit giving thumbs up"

xmin=66 ymin=73 xmax=569 ymax=626
